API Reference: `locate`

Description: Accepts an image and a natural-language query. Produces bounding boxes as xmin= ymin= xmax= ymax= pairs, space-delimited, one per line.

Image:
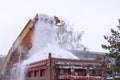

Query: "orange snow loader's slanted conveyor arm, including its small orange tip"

xmin=0 ymin=15 xmax=60 ymax=80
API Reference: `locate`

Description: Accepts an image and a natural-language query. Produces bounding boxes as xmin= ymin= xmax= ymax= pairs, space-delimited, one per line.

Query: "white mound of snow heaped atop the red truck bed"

xmin=25 ymin=44 xmax=78 ymax=63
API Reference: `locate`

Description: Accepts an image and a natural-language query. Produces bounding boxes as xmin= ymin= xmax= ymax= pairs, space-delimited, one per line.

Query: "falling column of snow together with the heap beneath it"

xmin=25 ymin=15 xmax=78 ymax=63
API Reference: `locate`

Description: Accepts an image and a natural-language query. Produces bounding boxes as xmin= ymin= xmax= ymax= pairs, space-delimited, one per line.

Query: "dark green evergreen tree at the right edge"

xmin=102 ymin=20 xmax=120 ymax=73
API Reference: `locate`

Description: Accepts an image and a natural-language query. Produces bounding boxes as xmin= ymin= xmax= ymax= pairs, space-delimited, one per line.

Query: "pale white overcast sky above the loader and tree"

xmin=0 ymin=0 xmax=120 ymax=55
